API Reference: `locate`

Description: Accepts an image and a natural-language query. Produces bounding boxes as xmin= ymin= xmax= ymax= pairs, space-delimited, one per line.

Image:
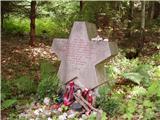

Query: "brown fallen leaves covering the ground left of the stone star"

xmin=1 ymin=36 xmax=57 ymax=80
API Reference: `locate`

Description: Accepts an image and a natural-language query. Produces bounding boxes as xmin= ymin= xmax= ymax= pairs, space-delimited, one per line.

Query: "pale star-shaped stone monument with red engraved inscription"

xmin=52 ymin=22 xmax=117 ymax=88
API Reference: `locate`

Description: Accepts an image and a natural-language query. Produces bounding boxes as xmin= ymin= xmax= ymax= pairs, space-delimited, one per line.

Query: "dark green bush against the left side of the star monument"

xmin=37 ymin=61 xmax=59 ymax=98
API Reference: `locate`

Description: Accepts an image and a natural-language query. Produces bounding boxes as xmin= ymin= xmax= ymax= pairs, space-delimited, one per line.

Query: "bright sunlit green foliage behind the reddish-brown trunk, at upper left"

xmin=4 ymin=1 xmax=79 ymax=38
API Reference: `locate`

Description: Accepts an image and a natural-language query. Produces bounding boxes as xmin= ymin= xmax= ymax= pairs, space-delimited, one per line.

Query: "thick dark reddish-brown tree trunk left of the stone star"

xmin=29 ymin=1 xmax=36 ymax=46
